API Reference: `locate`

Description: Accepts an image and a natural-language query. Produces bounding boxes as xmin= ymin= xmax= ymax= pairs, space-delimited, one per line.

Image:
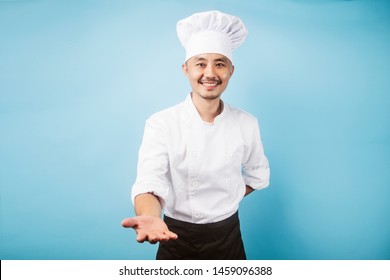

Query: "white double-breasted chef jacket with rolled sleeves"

xmin=132 ymin=94 xmax=270 ymax=224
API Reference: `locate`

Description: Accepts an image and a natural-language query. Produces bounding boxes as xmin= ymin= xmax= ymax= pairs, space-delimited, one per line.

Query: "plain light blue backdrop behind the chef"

xmin=0 ymin=0 xmax=390 ymax=259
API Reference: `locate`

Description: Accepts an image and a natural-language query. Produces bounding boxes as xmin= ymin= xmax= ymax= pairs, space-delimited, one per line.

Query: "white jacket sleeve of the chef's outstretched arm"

xmin=131 ymin=118 xmax=170 ymax=208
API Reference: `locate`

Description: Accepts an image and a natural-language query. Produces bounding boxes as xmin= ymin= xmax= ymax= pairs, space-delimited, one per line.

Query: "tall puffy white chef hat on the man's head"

xmin=176 ymin=11 xmax=248 ymax=61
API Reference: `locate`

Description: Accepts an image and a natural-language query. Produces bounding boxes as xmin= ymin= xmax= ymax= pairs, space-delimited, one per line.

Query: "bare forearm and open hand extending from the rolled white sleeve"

xmin=122 ymin=193 xmax=178 ymax=244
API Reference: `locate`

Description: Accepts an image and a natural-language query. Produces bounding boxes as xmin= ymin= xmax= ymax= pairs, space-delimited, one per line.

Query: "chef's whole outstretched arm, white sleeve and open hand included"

xmin=122 ymin=116 xmax=177 ymax=243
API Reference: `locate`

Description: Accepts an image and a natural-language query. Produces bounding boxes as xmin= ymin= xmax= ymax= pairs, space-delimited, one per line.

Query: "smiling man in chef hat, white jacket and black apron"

xmin=122 ymin=11 xmax=270 ymax=259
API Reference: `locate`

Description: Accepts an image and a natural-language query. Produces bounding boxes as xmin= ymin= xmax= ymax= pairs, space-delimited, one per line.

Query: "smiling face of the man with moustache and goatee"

xmin=182 ymin=53 xmax=234 ymax=100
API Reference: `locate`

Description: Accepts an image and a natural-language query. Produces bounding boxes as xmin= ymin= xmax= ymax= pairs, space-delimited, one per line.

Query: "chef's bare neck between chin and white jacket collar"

xmin=191 ymin=94 xmax=222 ymax=123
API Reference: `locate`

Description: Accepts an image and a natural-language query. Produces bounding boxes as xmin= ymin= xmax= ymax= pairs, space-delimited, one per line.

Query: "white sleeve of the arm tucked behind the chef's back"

xmin=242 ymin=119 xmax=270 ymax=190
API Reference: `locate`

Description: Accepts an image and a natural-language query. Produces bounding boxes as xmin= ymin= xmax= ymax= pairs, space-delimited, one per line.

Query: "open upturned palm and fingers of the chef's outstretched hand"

xmin=122 ymin=216 xmax=178 ymax=244
